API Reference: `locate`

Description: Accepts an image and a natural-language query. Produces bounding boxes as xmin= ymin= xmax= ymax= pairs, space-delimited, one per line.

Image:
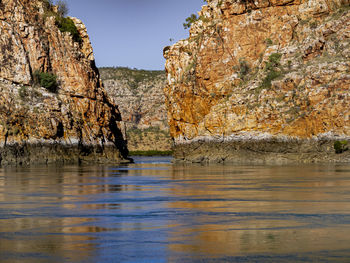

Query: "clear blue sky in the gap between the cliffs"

xmin=66 ymin=0 xmax=205 ymax=69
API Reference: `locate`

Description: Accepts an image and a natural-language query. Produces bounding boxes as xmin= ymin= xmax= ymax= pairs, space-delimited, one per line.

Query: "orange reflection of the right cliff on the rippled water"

xmin=169 ymin=165 xmax=350 ymax=257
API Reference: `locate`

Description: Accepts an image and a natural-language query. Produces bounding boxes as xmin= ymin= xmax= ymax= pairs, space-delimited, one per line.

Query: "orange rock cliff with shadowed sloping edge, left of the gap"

xmin=0 ymin=0 xmax=127 ymax=165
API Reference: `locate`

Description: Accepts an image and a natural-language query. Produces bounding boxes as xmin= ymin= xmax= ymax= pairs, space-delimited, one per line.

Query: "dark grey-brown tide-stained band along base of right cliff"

xmin=174 ymin=138 xmax=350 ymax=164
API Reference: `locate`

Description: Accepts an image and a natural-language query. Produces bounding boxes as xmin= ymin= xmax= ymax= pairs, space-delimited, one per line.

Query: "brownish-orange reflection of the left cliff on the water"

xmin=0 ymin=167 xmax=122 ymax=262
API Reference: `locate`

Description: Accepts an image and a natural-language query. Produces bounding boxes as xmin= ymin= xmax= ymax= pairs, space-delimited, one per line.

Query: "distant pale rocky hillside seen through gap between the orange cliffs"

xmin=99 ymin=68 xmax=172 ymax=151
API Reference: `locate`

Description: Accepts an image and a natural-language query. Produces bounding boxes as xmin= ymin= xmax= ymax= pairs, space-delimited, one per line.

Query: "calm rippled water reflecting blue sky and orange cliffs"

xmin=0 ymin=158 xmax=350 ymax=263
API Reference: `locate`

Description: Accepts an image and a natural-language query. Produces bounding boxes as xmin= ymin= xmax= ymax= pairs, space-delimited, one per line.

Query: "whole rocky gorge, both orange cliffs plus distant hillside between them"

xmin=0 ymin=0 xmax=350 ymax=165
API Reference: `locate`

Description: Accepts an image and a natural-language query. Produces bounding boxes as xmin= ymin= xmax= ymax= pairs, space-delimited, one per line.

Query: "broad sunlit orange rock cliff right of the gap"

xmin=164 ymin=0 xmax=350 ymax=162
